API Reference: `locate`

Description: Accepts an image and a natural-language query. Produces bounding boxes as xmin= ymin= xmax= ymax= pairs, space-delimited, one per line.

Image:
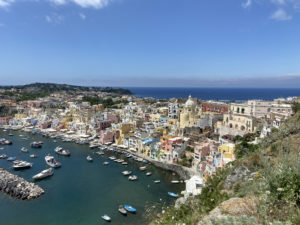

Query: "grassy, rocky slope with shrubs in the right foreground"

xmin=151 ymin=112 xmax=300 ymax=225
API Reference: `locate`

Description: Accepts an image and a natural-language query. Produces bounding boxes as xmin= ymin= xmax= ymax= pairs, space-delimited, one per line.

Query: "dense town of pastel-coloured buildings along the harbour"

xmin=0 ymin=90 xmax=298 ymax=195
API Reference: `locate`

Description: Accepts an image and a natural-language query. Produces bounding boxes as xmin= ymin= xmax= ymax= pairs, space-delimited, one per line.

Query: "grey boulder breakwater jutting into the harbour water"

xmin=0 ymin=168 xmax=45 ymax=200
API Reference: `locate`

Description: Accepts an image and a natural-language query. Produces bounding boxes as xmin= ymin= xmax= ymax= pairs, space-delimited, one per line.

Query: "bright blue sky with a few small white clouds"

xmin=0 ymin=0 xmax=300 ymax=87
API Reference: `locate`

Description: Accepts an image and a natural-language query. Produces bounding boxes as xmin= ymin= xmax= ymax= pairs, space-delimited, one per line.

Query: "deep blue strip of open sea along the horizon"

xmin=127 ymin=87 xmax=300 ymax=101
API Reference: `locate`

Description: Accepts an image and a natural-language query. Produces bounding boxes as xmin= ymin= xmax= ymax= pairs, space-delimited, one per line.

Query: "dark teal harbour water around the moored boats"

xmin=0 ymin=130 xmax=184 ymax=225
